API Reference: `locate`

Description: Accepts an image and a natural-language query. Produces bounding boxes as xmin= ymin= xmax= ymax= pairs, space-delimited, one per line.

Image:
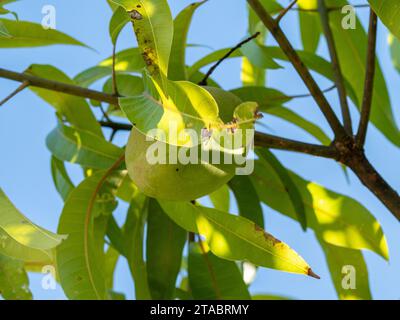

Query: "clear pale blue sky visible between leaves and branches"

xmin=0 ymin=0 xmax=400 ymax=299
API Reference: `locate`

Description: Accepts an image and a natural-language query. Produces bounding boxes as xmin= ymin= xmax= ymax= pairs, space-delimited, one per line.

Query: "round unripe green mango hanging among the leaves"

xmin=125 ymin=128 xmax=235 ymax=201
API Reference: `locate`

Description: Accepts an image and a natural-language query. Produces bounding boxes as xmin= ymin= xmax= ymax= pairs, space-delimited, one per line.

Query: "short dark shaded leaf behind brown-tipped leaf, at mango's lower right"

xmin=229 ymin=176 xmax=264 ymax=228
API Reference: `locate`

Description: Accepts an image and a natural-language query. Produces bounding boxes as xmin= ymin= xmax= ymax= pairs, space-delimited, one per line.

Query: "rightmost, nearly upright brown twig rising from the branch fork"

xmin=356 ymin=9 xmax=378 ymax=147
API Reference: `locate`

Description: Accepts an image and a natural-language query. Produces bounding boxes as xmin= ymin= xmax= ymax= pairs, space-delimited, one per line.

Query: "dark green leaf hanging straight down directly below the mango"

xmin=146 ymin=199 xmax=187 ymax=300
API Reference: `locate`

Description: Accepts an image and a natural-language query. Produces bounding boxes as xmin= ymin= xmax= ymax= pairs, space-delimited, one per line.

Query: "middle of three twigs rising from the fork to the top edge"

xmin=318 ymin=0 xmax=353 ymax=135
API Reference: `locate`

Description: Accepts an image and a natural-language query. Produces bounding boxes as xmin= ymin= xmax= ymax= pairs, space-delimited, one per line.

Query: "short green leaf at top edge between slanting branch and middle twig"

xmin=297 ymin=0 xmax=322 ymax=52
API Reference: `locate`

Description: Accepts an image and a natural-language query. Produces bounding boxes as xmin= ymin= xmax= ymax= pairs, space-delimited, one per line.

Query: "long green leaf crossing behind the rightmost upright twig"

xmin=327 ymin=0 xmax=400 ymax=146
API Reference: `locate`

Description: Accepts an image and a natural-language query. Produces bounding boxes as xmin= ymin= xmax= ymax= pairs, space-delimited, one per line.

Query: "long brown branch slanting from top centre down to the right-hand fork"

xmin=247 ymin=0 xmax=347 ymax=138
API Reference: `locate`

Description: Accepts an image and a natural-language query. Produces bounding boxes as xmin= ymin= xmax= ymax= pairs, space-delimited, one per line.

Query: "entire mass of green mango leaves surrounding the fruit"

xmin=0 ymin=0 xmax=400 ymax=299
